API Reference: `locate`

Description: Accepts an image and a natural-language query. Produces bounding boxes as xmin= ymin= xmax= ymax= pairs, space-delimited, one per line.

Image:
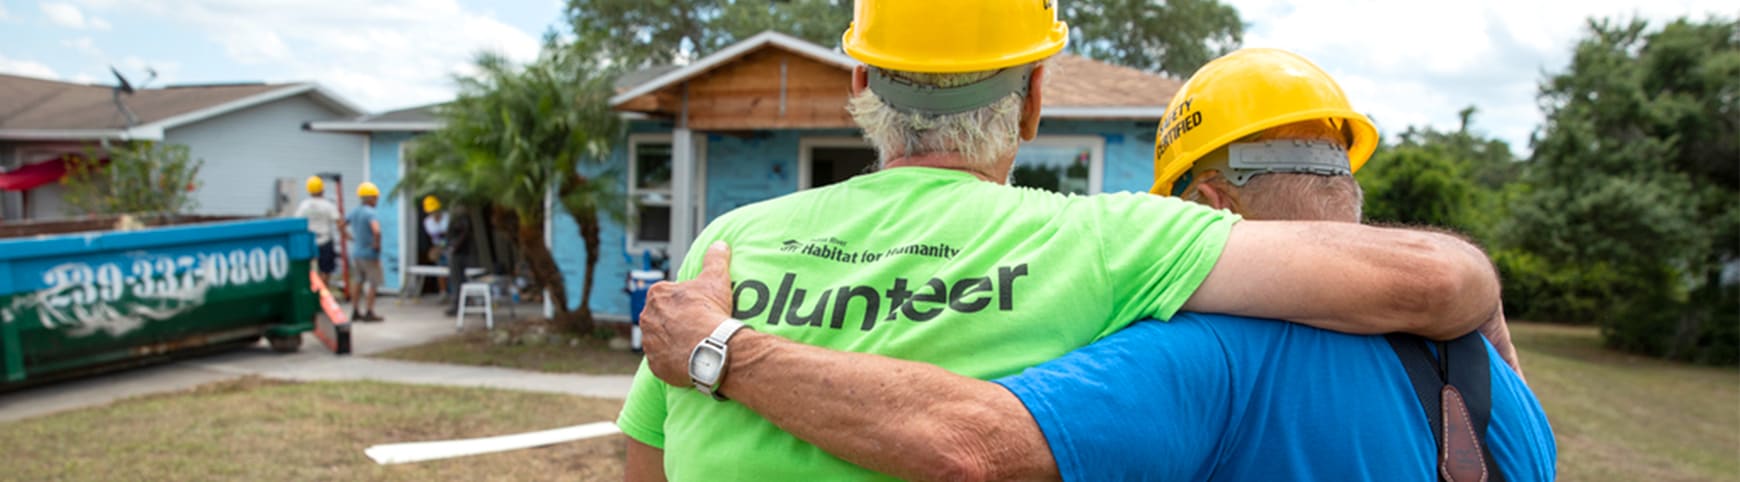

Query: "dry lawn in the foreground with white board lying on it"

xmin=0 ymin=378 xmax=623 ymax=480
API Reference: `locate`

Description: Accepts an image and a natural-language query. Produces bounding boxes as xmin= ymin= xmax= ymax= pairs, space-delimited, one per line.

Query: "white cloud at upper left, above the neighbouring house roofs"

xmin=75 ymin=0 xmax=539 ymax=110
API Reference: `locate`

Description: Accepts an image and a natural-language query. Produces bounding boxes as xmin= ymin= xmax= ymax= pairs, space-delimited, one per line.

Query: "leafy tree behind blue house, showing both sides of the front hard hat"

xmin=567 ymin=0 xmax=1244 ymax=77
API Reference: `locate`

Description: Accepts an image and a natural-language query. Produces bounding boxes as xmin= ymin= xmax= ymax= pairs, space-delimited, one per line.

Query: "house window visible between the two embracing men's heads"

xmin=1009 ymin=136 xmax=1105 ymax=195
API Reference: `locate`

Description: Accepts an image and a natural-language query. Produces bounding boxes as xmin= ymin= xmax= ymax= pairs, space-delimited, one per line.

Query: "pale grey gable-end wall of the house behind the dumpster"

xmin=164 ymin=96 xmax=367 ymax=216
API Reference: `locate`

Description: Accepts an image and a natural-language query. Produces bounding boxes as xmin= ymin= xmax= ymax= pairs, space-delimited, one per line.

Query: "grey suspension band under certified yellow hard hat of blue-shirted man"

xmin=1192 ymin=141 xmax=1354 ymax=186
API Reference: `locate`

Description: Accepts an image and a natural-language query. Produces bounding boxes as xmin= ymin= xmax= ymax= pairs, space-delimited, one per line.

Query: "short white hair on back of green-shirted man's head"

xmin=846 ymin=70 xmax=1025 ymax=167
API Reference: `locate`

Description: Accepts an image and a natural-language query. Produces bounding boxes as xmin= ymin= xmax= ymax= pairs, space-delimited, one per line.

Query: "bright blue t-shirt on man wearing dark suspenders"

xmin=997 ymin=313 xmax=1557 ymax=482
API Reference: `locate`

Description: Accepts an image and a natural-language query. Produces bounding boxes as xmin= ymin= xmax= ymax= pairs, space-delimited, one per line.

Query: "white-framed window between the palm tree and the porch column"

xmin=628 ymin=136 xmax=672 ymax=250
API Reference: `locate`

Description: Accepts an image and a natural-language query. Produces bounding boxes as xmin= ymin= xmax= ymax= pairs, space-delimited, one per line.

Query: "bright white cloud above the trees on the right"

xmin=1228 ymin=0 xmax=1731 ymax=155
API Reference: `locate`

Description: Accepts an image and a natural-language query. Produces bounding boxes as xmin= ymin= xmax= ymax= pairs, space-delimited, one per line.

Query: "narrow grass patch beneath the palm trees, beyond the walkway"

xmin=372 ymin=331 xmax=640 ymax=374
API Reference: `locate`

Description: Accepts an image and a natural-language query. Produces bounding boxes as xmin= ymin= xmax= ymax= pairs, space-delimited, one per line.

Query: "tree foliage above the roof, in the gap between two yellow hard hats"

xmin=1060 ymin=0 xmax=1244 ymax=78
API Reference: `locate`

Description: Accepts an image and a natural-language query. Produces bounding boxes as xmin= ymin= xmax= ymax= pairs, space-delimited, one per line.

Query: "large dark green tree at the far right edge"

xmin=1505 ymin=17 xmax=1740 ymax=364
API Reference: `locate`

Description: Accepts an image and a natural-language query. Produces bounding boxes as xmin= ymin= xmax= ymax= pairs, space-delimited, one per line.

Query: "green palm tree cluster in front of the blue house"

xmin=400 ymin=38 xmax=626 ymax=332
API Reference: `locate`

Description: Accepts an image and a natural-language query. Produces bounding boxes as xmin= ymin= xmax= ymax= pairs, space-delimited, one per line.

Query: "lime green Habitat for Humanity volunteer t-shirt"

xmin=618 ymin=167 xmax=1239 ymax=480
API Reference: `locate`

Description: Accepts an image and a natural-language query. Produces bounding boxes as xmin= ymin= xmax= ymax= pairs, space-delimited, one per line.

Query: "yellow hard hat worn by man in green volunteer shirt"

xmin=840 ymin=0 xmax=1070 ymax=73
